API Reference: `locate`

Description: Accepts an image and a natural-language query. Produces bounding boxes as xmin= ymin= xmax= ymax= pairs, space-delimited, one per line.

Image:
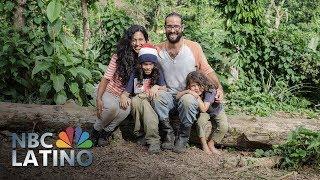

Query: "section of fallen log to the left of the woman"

xmin=0 ymin=101 xmax=97 ymax=132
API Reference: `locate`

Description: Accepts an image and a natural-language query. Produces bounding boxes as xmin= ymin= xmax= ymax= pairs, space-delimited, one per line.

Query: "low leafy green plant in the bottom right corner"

xmin=274 ymin=127 xmax=320 ymax=169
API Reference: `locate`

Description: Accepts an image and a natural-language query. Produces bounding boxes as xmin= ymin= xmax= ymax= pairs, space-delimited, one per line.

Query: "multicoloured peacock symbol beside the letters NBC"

xmin=56 ymin=127 xmax=93 ymax=149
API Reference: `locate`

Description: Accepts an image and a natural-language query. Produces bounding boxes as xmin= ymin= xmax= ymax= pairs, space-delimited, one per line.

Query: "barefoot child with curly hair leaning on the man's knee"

xmin=177 ymin=71 xmax=228 ymax=154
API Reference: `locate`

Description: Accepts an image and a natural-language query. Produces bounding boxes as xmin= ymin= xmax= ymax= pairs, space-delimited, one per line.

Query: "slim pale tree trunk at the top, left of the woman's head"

xmin=81 ymin=0 xmax=90 ymax=56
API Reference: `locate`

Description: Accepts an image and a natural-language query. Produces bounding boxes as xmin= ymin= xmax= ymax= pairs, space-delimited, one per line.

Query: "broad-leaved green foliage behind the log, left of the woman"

xmin=0 ymin=0 xmax=105 ymax=105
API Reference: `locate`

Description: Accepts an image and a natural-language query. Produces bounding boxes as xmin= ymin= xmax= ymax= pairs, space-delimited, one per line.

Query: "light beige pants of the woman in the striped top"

xmin=93 ymin=91 xmax=131 ymax=132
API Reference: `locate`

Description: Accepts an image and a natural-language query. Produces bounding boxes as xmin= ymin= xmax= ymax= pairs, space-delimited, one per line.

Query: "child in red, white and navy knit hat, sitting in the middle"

xmin=122 ymin=44 xmax=166 ymax=154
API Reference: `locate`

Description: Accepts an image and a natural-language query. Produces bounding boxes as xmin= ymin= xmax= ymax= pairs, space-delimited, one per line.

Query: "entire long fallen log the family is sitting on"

xmin=0 ymin=101 xmax=320 ymax=149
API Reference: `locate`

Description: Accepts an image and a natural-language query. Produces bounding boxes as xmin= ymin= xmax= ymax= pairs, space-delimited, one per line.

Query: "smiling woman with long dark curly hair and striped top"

xmin=92 ymin=25 xmax=149 ymax=146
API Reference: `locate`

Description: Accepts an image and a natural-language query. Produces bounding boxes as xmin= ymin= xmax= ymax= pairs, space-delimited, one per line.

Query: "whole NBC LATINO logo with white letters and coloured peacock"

xmin=12 ymin=127 xmax=93 ymax=166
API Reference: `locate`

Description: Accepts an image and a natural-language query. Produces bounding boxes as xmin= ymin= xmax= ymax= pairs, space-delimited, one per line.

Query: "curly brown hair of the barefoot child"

xmin=186 ymin=71 xmax=214 ymax=91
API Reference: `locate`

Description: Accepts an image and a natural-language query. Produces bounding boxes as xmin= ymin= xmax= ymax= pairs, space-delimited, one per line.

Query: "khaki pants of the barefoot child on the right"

xmin=197 ymin=110 xmax=228 ymax=143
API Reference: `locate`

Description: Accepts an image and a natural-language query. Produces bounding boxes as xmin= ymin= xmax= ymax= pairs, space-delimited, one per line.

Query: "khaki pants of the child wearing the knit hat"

xmin=131 ymin=93 xmax=160 ymax=144
